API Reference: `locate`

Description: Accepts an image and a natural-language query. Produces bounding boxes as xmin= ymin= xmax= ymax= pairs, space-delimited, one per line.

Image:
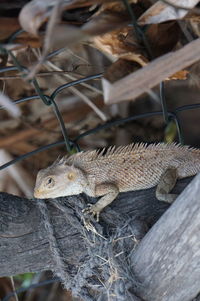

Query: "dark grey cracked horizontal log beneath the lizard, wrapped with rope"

xmin=0 ymin=178 xmax=191 ymax=276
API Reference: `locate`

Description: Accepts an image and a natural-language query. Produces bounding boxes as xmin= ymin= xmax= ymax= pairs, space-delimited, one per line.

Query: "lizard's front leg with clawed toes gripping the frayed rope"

xmin=83 ymin=183 xmax=119 ymax=222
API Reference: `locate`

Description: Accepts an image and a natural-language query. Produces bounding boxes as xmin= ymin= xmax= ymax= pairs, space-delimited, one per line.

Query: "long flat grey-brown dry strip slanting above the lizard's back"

xmin=102 ymin=38 xmax=200 ymax=104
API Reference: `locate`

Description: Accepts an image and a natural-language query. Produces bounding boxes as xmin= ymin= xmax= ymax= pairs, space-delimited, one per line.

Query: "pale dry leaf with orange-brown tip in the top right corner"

xmin=138 ymin=0 xmax=199 ymax=25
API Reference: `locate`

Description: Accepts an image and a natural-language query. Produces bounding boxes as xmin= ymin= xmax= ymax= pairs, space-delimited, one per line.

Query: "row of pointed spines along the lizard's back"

xmin=53 ymin=142 xmax=199 ymax=165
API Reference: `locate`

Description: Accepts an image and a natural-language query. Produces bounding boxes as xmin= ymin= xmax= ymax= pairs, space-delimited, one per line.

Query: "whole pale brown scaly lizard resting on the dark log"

xmin=34 ymin=143 xmax=200 ymax=221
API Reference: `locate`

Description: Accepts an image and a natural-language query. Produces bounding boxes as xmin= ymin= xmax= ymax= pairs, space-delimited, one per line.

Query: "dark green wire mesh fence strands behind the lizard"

xmin=0 ymin=0 xmax=197 ymax=170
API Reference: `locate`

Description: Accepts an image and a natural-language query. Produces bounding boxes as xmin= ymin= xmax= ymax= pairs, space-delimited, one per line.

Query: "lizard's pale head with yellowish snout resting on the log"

xmin=34 ymin=159 xmax=85 ymax=199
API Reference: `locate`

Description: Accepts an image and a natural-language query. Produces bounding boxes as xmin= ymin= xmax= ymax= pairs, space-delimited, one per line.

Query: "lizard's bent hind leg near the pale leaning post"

xmin=156 ymin=168 xmax=178 ymax=203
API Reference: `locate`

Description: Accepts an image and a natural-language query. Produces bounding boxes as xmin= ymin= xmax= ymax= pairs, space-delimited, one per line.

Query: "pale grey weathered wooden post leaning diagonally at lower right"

xmin=133 ymin=174 xmax=200 ymax=301
